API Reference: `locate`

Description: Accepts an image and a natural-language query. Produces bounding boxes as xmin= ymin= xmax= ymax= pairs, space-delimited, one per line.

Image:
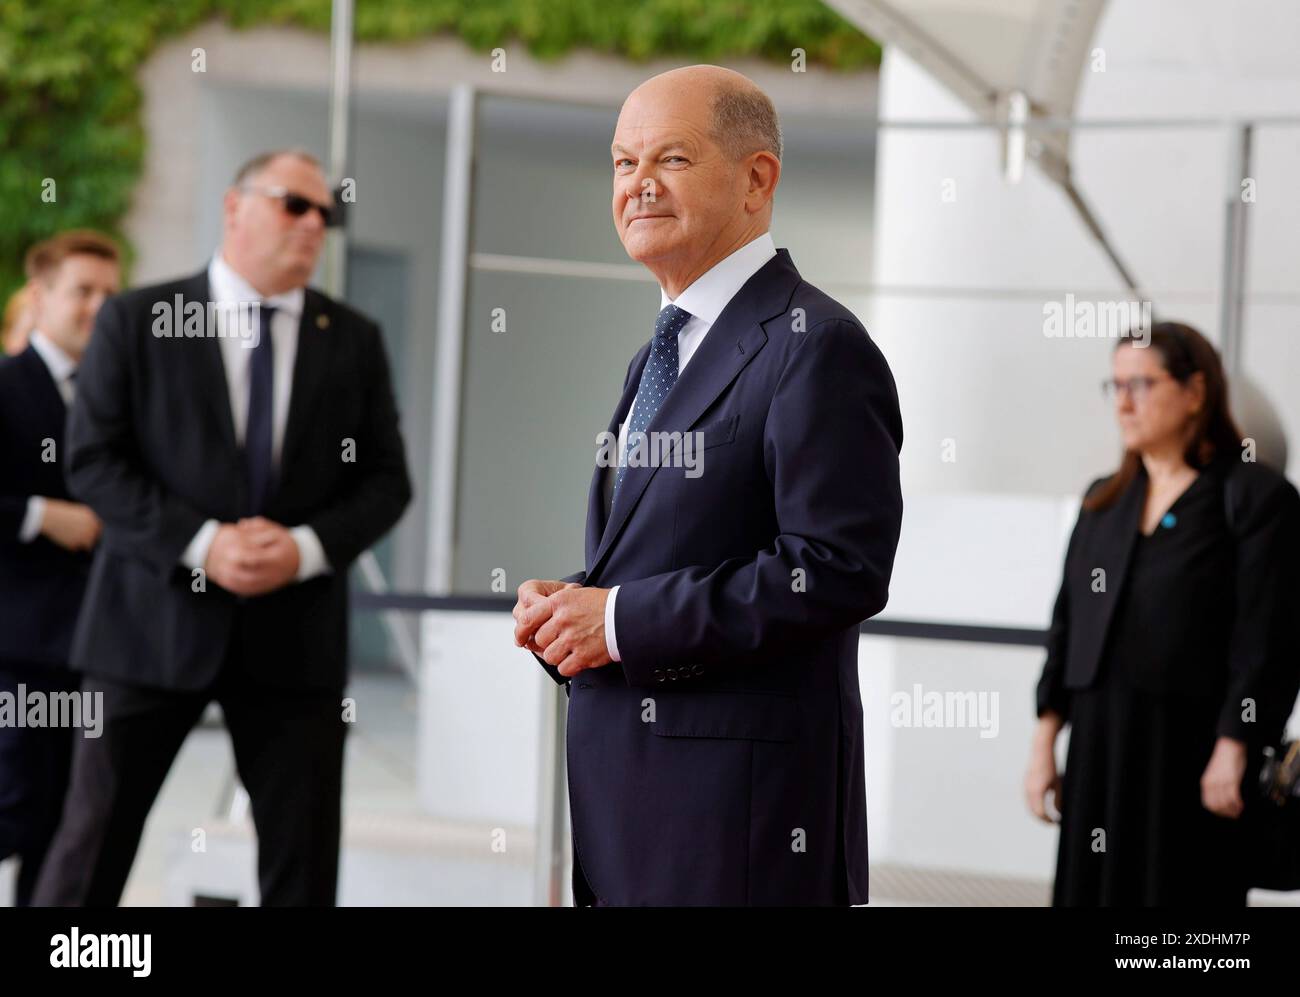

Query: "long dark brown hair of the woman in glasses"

xmin=1083 ymin=322 xmax=1242 ymax=512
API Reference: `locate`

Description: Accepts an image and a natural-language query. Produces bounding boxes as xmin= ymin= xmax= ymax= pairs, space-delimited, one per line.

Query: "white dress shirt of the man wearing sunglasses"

xmin=181 ymin=252 xmax=330 ymax=581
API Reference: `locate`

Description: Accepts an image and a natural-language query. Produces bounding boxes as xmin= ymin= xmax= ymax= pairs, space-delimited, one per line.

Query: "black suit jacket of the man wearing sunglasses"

xmin=68 ymin=272 xmax=411 ymax=689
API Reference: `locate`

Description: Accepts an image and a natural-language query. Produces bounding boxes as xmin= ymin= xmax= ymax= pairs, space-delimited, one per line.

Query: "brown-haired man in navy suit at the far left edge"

xmin=0 ymin=231 xmax=120 ymax=906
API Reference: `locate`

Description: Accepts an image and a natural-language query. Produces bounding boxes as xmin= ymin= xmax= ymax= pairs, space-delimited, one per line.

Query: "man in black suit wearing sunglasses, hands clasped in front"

xmin=36 ymin=152 xmax=411 ymax=906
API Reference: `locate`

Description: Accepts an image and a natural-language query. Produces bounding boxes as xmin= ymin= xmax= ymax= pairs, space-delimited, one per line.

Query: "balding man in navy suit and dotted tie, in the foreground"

xmin=515 ymin=66 xmax=902 ymax=906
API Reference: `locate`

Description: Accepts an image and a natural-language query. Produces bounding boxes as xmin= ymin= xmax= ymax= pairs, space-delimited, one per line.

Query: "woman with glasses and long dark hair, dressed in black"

xmin=1024 ymin=322 xmax=1300 ymax=906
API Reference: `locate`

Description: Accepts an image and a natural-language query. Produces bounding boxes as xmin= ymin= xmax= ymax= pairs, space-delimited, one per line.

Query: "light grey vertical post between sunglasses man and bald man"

xmin=425 ymin=83 xmax=477 ymax=595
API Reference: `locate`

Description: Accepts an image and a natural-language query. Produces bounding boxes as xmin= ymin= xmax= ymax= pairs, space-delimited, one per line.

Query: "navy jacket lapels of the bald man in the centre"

xmin=588 ymin=250 xmax=801 ymax=578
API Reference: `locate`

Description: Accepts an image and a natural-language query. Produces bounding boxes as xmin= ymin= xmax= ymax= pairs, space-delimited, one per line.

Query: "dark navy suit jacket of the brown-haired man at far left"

xmin=0 ymin=346 xmax=90 ymax=667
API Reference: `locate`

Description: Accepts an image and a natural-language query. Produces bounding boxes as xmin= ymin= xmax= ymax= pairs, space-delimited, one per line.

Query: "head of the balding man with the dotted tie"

xmin=611 ymin=65 xmax=783 ymax=296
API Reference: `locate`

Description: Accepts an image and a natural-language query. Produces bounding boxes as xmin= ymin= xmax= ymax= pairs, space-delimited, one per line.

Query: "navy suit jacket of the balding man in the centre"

xmin=547 ymin=250 xmax=902 ymax=905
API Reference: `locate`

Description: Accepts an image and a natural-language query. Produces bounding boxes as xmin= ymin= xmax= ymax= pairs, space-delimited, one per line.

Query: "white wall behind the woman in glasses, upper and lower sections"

xmin=863 ymin=0 xmax=1300 ymax=894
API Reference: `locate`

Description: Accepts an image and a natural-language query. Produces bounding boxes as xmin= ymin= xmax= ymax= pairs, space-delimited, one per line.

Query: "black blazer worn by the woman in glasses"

xmin=1036 ymin=455 xmax=1300 ymax=745
